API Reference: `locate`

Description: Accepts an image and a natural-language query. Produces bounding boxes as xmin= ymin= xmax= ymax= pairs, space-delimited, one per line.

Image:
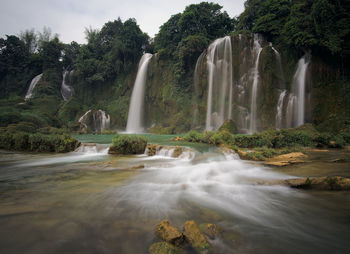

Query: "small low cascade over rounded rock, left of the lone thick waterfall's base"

xmin=78 ymin=109 xmax=111 ymax=133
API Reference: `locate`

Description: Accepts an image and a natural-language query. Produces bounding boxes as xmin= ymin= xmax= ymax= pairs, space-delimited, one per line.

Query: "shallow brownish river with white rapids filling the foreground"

xmin=0 ymin=135 xmax=350 ymax=253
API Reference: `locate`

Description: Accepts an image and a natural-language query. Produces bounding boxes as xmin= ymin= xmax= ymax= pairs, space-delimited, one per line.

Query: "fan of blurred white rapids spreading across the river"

xmin=110 ymin=152 xmax=293 ymax=219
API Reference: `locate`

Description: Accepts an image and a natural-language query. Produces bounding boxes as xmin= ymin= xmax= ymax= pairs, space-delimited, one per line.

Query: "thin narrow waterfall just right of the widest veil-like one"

xmin=249 ymin=34 xmax=262 ymax=133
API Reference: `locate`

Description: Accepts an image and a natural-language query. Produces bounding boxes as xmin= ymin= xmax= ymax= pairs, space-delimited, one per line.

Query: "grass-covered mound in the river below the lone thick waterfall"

xmin=109 ymin=135 xmax=147 ymax=154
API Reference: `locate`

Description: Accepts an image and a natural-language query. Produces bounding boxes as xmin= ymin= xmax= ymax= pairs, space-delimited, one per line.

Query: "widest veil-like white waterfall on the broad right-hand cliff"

xmin=205 ymin=36 xmax=233 ymax=130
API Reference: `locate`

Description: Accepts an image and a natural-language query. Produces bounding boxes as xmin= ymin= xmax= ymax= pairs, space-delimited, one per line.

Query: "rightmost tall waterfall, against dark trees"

xmin=286 ymin=54 xmax=310 ymax=128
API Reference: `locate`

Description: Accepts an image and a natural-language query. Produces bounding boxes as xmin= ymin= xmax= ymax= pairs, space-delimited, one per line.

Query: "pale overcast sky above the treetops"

xmin=0 ymin=0 xmax=245 ymax=43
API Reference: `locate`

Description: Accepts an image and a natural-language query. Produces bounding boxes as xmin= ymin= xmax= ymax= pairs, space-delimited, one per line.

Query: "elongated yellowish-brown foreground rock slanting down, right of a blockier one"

xmin=183 ymin=220 xmax=210 ymax=254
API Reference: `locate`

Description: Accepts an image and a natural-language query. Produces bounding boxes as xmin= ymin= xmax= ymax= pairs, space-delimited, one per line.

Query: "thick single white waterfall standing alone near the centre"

xmin=126 ymin=53 xmax=152 ymax=133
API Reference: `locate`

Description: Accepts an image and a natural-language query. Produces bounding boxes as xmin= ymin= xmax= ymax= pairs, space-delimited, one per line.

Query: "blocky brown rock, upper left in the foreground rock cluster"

xmin=156 ymin=220 xmax=184 ymax=246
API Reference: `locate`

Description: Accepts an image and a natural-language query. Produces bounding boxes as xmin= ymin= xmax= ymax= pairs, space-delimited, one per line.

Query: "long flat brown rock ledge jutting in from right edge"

xmin=285 ymin=176 xmax=350 ymax=190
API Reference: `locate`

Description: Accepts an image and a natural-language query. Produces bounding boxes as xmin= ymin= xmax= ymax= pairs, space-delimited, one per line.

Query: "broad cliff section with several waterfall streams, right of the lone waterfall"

xmin=192 ymin=34 xmax=310 ymax=134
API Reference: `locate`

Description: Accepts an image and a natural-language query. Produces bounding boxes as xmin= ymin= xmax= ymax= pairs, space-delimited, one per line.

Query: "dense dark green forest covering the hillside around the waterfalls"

xmin=0 ymin=0 xmax=350 ymax=136
